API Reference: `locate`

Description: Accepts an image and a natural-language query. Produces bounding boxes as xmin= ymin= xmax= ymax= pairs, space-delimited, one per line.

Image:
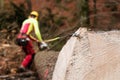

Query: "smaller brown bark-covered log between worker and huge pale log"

xmin=34 ymin=51 xmax=58 ymax=80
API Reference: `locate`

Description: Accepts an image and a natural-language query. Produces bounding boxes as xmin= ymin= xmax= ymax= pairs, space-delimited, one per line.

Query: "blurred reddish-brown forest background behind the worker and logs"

xmin=0 ymin=0 xmax=120 ymax=49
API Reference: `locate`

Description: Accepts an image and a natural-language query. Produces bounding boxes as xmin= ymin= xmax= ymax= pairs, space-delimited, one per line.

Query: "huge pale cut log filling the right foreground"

xmin=52 ymin=28 xmax=120 ymax=80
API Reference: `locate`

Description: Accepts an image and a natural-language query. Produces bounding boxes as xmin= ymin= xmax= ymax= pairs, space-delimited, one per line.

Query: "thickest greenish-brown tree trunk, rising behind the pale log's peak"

xmin=77 ymin=0 xmax=89 ymax=27
